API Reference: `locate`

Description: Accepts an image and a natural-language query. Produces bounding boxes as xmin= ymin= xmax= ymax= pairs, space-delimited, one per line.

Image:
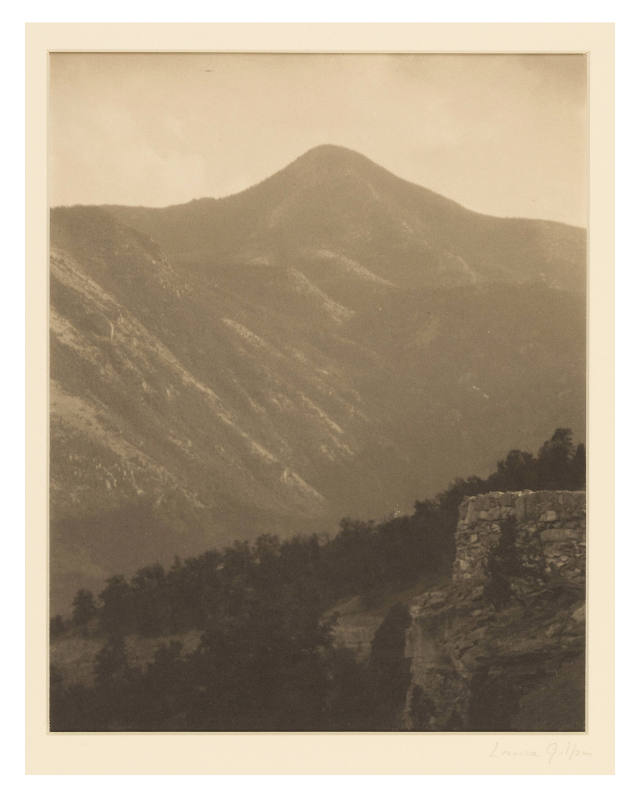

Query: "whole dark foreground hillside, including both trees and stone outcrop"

xmin=51 ymin=429 xmax=585 ymax=731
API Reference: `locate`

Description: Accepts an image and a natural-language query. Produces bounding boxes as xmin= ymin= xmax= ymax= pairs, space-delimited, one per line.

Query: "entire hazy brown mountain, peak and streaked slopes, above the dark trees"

xmin=51 ymin=148 xmax=585 ymax=604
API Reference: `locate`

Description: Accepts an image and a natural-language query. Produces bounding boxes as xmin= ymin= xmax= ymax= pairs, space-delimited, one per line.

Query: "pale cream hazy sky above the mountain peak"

xmin=50 ymin=54 xmax=587 ymax=225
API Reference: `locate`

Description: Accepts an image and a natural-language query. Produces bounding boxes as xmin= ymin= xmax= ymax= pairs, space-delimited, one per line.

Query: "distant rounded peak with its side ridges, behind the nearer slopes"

xmin=104 ymin=145 xmax=586 ymax=290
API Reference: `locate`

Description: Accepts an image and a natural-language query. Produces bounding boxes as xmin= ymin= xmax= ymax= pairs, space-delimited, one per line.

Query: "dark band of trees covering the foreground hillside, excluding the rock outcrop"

xmin=50 ymin=428 xmax=585 ymax=731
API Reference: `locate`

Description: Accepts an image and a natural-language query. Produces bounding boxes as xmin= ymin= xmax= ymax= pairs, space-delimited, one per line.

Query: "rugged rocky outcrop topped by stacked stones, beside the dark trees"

xmin=404 ymin=491 xmax=585 ymax=731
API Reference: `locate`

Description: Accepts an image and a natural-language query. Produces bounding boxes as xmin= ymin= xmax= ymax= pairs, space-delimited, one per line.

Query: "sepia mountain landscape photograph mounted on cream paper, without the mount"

xmin=47 ymin=51 xmax=592 ymax=736
